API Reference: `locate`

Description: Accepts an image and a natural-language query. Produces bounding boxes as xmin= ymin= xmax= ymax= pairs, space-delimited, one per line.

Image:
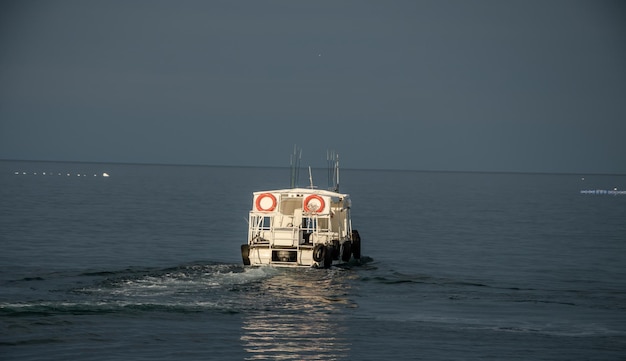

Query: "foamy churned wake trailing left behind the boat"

xmin=0 ymin=264 xmax=279 ymax=316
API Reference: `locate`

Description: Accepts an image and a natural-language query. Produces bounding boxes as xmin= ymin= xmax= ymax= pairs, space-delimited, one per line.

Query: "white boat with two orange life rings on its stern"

xmin=241 ymin=152 xmax=361 ymax=268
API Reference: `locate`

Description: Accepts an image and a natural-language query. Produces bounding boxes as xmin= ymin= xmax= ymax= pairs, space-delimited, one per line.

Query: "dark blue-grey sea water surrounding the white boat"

xmin=0 ymin=161 xmax=626 ymax=360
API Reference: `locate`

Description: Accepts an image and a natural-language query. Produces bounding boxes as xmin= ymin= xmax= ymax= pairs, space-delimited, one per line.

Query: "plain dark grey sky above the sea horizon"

xmin=0 ymin=0 xmax=626 ymax=173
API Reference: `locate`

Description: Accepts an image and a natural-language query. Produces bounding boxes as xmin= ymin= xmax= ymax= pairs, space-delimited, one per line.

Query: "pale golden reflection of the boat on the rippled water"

xmin=241 ymin=269 xmax=354 ymax=360
